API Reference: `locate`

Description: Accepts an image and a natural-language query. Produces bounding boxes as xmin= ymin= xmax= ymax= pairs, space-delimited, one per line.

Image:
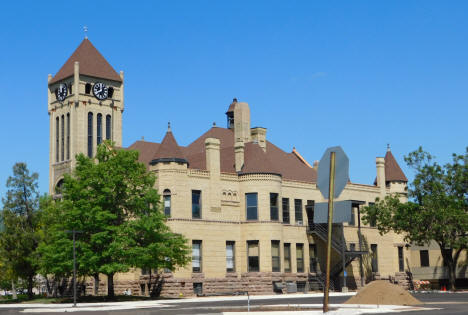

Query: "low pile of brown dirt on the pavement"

xmin=345 ymin=280 xmax=423 ymax=305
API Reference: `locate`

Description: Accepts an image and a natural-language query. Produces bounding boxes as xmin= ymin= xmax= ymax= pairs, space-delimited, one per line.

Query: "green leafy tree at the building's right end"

xmin=363 ymin=147 xmax=468 ymax=290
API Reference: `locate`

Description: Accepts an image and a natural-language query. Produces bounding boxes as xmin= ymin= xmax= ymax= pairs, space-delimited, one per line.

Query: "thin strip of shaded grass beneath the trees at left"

xmin=0 ymin=294 xmax=160 ymax=304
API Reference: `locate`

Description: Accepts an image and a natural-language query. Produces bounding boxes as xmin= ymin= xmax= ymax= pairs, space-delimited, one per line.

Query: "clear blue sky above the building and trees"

xmin=0 ymin=0 xmax=468 ymax=196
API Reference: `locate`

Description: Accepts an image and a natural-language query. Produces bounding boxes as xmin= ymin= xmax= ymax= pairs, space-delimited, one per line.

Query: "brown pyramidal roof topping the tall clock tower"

xmin=49 ymin=38 xmax=122 ymax=84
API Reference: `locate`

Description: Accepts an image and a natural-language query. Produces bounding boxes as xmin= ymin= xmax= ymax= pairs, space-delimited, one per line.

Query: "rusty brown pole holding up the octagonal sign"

xmin=323 ymin=152 xmax=335 ymax=313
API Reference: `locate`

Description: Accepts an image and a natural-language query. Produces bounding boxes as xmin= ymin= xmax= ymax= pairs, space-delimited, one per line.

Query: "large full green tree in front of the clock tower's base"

xmin=49 ymin=142 xmax=188 ymax=297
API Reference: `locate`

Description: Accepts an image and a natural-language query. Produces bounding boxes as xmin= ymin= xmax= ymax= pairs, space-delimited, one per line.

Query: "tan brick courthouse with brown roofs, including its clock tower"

xmin=48 ymin=39 xmax=410 ymax=296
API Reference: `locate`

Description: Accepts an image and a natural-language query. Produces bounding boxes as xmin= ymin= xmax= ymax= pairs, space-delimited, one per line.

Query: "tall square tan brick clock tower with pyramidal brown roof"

xmin=47 ymin=38 xmax=124 ymax=194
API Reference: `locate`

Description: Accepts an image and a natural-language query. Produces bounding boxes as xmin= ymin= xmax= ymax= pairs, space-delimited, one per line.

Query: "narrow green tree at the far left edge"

xmin=0 ymin=163 xmax=40 ymax=298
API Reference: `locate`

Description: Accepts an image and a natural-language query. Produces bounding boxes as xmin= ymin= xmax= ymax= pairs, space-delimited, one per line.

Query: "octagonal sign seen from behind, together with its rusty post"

xmin=314 ymin=147 xmax=350 ymax=313
